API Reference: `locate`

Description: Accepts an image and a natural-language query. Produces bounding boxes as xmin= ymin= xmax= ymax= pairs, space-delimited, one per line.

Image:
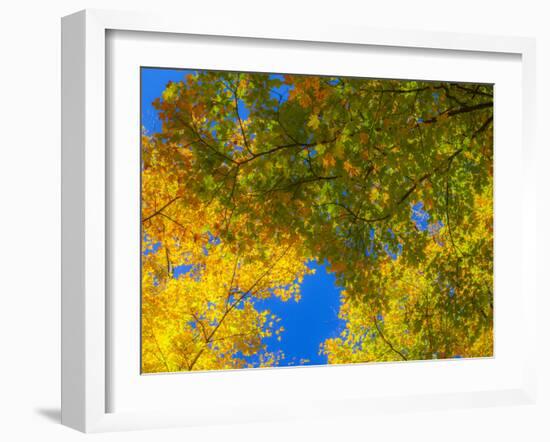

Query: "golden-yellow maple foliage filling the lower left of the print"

xmin=142 ymin=137 xmax=312 ymax=373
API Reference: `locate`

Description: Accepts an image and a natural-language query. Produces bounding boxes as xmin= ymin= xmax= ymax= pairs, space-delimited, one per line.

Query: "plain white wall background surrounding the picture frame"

xmin=0 ymin=0 xmax=550 ymax=442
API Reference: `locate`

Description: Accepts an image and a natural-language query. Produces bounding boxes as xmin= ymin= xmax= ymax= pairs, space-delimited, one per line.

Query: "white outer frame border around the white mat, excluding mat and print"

xmin=62 ymin=10 xmax=536 ymax=432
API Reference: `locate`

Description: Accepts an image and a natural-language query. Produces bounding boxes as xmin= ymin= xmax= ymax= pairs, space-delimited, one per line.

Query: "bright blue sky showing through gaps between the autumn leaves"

xmin=141 ymin=68 xmax=344 ymax=365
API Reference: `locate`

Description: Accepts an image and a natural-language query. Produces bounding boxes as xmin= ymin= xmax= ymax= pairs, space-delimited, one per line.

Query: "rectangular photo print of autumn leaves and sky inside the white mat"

xmin=142 ymin=67 xmax=493 ymax=374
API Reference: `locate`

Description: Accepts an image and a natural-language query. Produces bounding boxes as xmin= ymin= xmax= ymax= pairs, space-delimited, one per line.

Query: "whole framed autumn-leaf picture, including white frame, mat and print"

xmin=62 ymin=11 xmax=536 ymax=432
